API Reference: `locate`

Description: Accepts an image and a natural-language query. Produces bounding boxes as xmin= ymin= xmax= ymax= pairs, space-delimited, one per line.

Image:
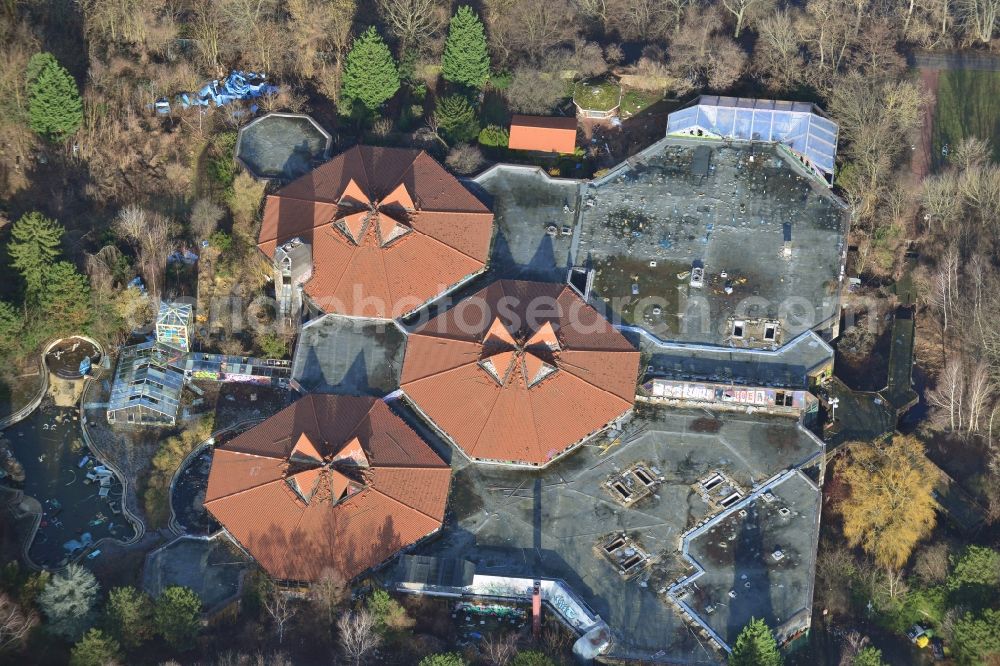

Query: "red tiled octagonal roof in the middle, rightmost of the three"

xmin=400 ymin=280 xmax=639 ymax=465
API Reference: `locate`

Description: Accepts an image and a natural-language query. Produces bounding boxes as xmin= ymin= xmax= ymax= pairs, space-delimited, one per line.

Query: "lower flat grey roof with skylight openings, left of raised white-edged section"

xmin=416 ymin=405 xmax=821 ymax=663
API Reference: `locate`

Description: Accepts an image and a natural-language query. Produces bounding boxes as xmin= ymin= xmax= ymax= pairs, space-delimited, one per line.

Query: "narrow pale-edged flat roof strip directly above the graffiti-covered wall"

xmin=622 ymin=329 xmax=833 ymax=389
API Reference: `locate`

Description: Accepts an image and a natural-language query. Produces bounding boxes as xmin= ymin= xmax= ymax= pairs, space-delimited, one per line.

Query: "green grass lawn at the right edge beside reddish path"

xmin=931 ymin=70 xmax=1000 ymax=166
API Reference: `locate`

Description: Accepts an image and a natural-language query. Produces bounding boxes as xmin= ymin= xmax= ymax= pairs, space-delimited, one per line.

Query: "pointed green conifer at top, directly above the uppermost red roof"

xmin=341 ymin=26 xmax=399 ymax=111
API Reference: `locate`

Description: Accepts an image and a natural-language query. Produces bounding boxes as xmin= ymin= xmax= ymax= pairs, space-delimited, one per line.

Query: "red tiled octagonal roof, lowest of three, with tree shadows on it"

xmin=205 ymin=395 xmax=451 ymax=581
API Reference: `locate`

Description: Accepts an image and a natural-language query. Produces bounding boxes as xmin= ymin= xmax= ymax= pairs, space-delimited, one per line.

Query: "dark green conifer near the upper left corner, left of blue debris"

xmin=27 ymin=53 xmax=83 ymax=143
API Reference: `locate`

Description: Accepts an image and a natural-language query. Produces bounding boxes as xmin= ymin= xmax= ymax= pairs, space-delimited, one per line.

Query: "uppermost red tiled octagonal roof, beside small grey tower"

xmin=258 ymin=146 xmax=493 ymax=318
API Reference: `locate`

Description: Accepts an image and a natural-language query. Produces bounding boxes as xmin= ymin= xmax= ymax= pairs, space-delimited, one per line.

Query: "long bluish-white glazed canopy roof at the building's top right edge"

xmin=667 ymin=95 xmax=838 ymax=183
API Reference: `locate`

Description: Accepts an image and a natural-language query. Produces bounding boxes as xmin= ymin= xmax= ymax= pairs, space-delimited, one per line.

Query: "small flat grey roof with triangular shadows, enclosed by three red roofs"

xmin=292 ymin=315 xmax=406 ymax=397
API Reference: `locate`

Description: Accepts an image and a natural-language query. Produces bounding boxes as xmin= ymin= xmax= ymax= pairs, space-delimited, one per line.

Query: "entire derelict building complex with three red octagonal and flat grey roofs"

xmin=105 ymin=98 xmax=848 ymax=663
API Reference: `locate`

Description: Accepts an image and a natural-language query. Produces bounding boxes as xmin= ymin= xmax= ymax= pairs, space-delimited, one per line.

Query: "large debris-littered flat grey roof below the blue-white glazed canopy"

xmin=574 ymin=139 xmax=847 ymax=343
